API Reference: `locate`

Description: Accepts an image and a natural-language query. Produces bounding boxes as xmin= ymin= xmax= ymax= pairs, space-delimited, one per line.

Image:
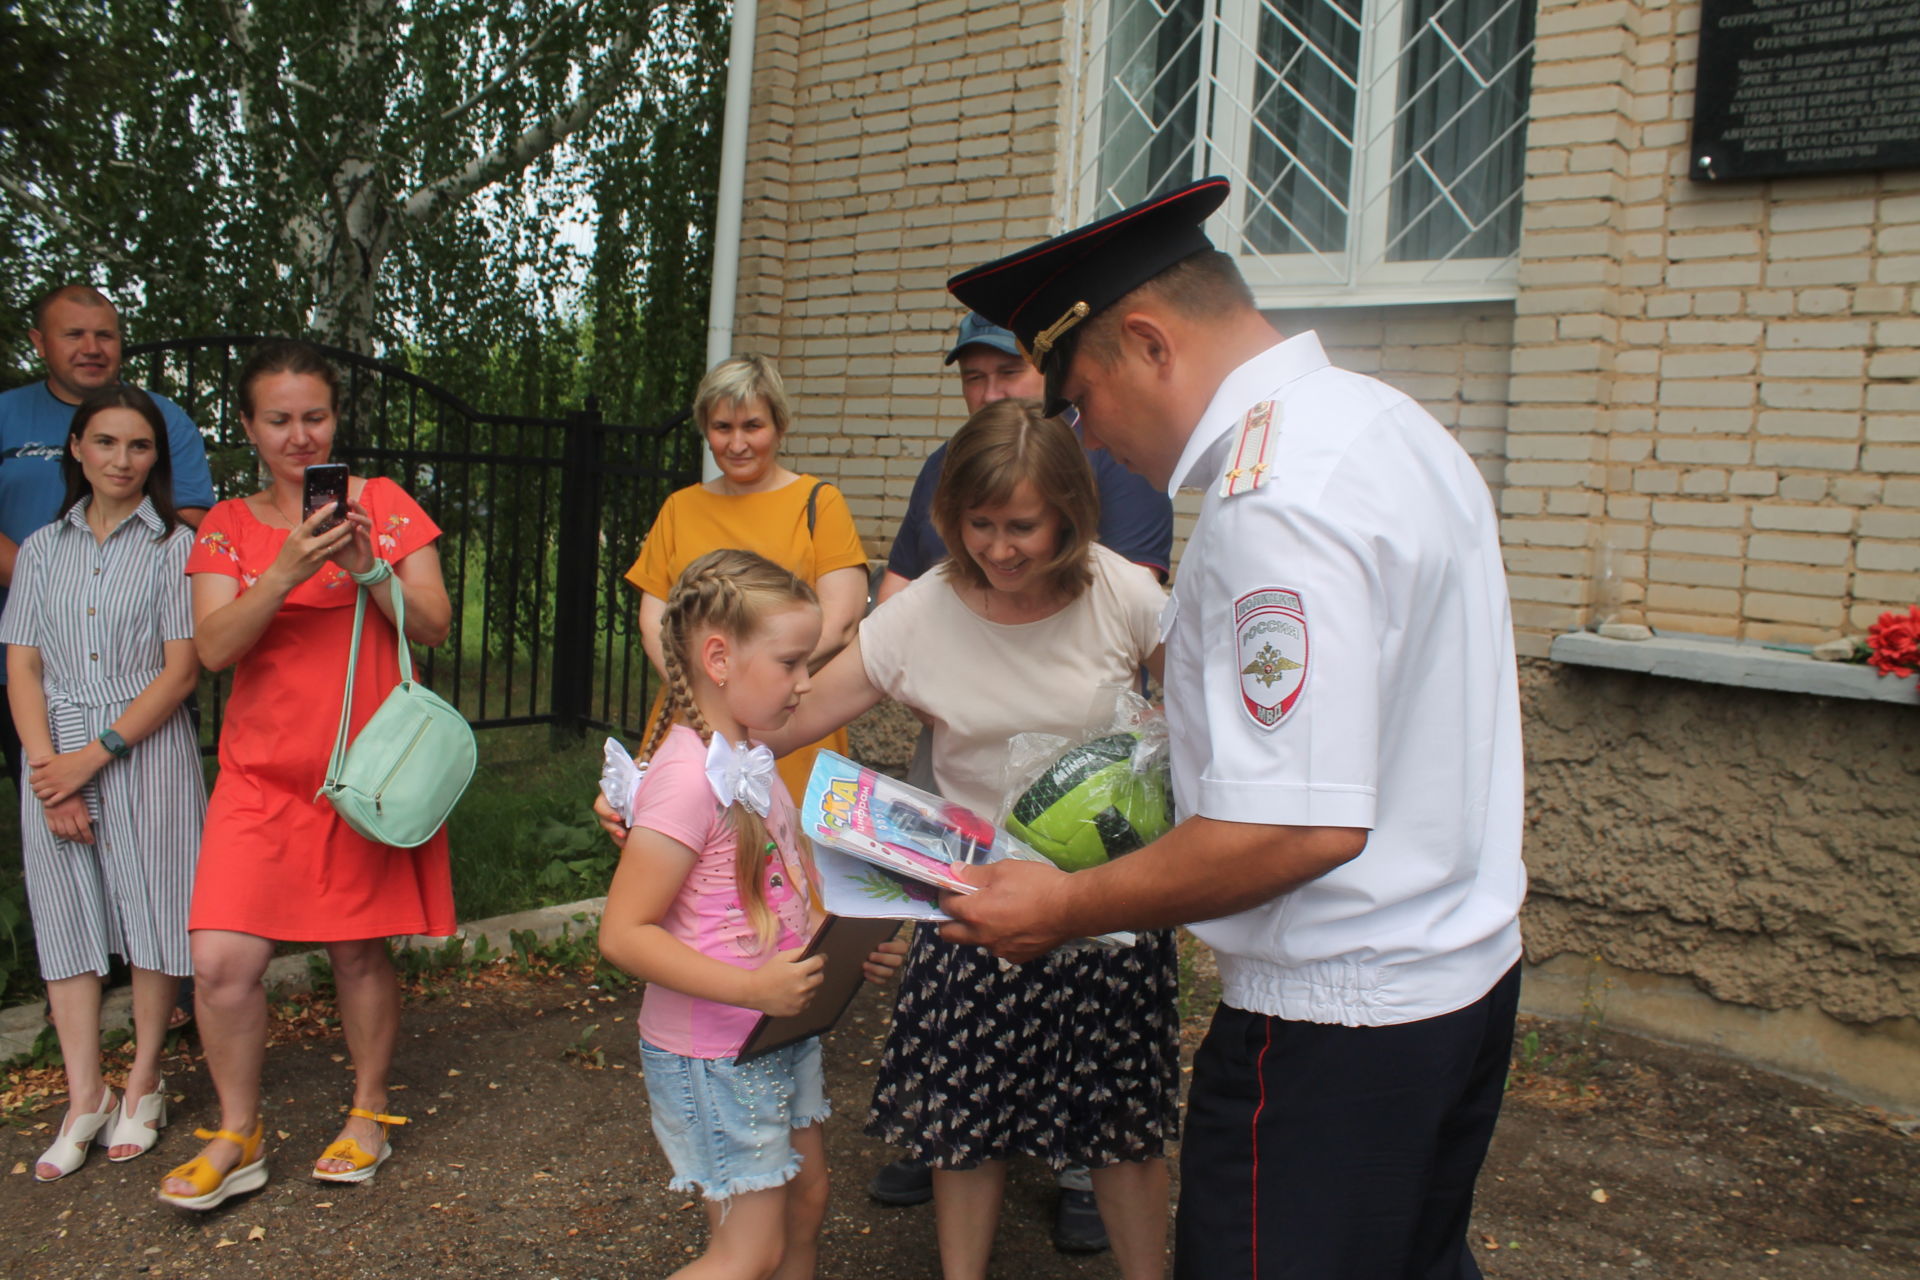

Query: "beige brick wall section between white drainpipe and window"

xmin=733 ymin=0 xmax=1064 ymax=537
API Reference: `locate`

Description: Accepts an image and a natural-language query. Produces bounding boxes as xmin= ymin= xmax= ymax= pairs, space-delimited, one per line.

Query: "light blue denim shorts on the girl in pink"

xmin=639 ymin=1038 xmax=831 ymax=1199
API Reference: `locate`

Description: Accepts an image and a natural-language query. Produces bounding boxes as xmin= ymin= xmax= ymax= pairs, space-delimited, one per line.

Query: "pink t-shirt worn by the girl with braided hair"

xmin=632 ymin=725 xmax=810 ymax=1057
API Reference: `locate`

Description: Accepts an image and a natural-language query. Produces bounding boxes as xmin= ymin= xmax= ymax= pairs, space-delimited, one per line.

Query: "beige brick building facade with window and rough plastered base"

xmin=735 ymin=0 xmax=1920 ymax=1105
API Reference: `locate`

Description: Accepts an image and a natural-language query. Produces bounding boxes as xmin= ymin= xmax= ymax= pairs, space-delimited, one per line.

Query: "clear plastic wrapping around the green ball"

xmin=998 ymin=689 xmax=1173 ymax=871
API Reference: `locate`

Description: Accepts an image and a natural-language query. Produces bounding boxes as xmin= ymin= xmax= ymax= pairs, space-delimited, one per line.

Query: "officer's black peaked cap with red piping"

xmin=947 ymin=178 xmax=1227 ymax=411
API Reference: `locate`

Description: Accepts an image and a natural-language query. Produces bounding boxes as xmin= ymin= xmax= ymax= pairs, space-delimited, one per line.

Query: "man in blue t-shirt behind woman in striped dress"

xmin=0 ymin=284 xmax=213 ymax=783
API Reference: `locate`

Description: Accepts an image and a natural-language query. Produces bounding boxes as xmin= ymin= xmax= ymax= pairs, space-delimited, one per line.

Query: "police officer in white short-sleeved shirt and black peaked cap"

xmin=943 ymin=178 xmax=1524 ymax=1280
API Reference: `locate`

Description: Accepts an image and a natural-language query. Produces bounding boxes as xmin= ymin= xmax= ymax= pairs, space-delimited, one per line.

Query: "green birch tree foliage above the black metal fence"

xmin=0 ymin=0 xmax=728 ymax=420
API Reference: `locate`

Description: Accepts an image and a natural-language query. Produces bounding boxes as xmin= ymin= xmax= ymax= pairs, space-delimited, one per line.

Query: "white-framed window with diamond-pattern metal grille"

xmin=1075 ymin=0 xmax=1534 ymax=305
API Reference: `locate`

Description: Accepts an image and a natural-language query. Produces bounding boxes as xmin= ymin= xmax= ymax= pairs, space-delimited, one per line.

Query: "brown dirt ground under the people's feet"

xmin=0 ymin=955 xmax=1920 ymax=1280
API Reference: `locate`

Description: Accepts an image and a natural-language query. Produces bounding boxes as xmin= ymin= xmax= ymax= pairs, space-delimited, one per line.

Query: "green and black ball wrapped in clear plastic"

xmin=1006 ymin=733 xmax=1173 ymax=871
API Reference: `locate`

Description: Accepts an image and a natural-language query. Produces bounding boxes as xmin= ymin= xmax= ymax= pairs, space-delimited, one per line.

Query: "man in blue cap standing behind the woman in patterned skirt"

xmin=866 ymin=313 xmax=1173 ymax=1253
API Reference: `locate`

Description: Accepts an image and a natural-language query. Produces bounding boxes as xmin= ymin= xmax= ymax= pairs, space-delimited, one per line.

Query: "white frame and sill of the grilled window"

xmin=1069 ymin=0 xmax=1530 ymax=307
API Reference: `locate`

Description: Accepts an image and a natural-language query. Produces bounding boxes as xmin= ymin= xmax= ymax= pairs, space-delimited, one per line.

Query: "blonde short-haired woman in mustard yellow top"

xmin=626 ymin=355 xmax=866 ymax=804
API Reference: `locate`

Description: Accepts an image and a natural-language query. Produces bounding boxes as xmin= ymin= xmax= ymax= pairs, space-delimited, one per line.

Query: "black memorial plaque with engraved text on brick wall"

xmin=1690 ymin=0 xmax=1920 ymax=182
